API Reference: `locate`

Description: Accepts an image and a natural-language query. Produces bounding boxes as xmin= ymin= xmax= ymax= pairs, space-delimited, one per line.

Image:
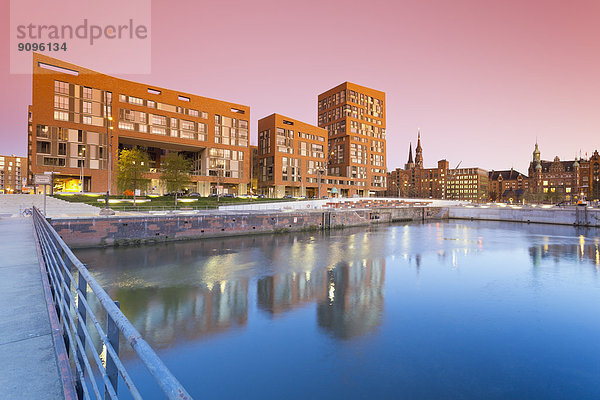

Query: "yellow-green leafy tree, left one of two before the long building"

xmin=117 ymin=148 xmax=150 ymax=204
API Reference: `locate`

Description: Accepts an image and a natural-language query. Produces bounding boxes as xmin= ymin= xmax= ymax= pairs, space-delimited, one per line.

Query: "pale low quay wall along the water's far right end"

xmin=448 ymin=207 xmax=600 ymax=227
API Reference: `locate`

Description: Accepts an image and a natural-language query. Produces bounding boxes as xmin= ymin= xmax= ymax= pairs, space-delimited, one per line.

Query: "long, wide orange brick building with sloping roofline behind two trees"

xmin=28 ymin=54 xmax=251 ymax=195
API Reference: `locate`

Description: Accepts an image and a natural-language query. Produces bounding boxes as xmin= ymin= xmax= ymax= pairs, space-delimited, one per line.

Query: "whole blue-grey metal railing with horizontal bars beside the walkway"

xmin=33 ymin=207 xmax=191 ymax=399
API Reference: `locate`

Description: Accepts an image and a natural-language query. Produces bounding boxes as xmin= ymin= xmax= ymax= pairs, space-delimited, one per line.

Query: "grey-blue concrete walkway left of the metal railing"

xmin=0 ymin=218 xmax=65 ymax=399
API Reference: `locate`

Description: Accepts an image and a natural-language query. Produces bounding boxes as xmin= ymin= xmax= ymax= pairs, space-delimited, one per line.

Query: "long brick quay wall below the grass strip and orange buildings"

xmin=50 ymin=207 xmax=448 ymax=247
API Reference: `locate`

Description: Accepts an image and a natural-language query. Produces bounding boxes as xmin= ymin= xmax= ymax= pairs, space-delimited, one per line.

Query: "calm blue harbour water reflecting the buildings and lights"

xmin=77 ymin=222 xmax=600 ymax=399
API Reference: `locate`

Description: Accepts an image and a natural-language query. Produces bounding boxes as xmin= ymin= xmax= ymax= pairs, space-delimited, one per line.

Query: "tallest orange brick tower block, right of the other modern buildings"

xmin=318 ymin=82 xmax=387 ymax=196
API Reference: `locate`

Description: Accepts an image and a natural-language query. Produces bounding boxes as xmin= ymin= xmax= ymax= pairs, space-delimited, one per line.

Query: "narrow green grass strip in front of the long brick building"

xmin=53 ymin=194 xmax=293 ymax=211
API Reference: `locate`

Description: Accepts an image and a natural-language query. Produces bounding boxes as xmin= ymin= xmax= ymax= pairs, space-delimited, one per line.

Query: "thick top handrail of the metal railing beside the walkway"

xmin=33 ymin=207 xmax=192 ymax=399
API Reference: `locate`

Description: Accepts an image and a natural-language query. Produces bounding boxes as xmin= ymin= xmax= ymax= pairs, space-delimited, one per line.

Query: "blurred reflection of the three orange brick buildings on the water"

xmin=77 ymin=229 xmax=386 ymax=355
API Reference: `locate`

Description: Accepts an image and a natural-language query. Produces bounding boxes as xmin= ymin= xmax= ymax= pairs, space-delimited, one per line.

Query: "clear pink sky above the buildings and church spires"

xmin=0 ymin=0 xmax=600 ymax=173
